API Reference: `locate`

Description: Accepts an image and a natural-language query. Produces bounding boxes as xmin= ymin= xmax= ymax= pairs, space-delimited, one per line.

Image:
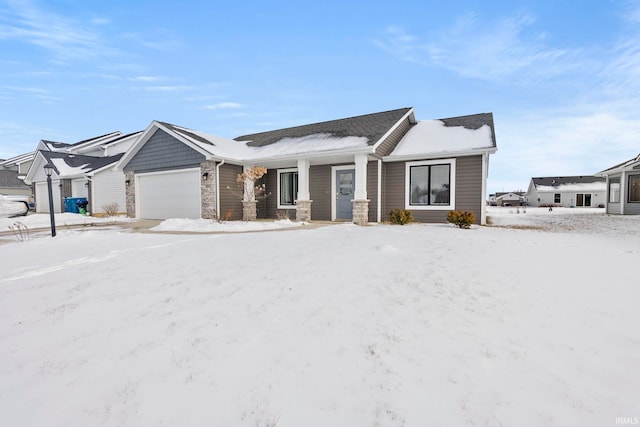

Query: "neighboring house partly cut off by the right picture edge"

xmin=596 ymin=154 xmax=640 ymax=215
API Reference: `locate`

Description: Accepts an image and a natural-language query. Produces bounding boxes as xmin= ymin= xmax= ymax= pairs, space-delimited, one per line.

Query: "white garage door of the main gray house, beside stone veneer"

xmin=136 ymin=168 xmax=200 ymax=219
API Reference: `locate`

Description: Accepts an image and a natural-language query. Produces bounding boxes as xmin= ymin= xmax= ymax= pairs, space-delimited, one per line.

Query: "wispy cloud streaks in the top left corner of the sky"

xmin=0 ymin=0 xmax=117 ymax=61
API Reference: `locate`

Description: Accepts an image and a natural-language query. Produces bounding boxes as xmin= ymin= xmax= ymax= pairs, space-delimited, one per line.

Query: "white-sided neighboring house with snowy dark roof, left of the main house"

xmin=25 ymin=131 xmax=142 ymax=215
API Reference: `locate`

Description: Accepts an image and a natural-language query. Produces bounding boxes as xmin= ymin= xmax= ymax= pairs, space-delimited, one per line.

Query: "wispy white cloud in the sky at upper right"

xmin=374 ymin=13 xmax=579 ymax=80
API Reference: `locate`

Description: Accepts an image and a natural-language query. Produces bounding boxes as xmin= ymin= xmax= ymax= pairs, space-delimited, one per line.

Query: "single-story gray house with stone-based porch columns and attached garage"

xmin=116 ymin=108 xmax=496 ymax=224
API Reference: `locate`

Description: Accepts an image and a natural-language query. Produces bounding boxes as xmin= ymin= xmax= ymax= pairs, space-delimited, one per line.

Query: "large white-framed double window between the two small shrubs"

xmin=406 ymin=159 xmax=455 ymax=210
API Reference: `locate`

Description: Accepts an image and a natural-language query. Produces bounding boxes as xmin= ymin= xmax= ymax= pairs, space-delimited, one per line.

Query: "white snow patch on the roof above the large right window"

xmin=389 ymin=120 xmax=494 ymax=157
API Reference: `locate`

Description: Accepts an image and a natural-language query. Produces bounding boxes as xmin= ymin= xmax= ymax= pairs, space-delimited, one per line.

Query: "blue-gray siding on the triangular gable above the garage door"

xmin=124 ymin=129 xmax=205 ymax=173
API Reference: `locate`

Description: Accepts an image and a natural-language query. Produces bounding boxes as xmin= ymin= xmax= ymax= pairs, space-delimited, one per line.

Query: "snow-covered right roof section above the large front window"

xmin=386 ymin=113 xmax=496 ymax=160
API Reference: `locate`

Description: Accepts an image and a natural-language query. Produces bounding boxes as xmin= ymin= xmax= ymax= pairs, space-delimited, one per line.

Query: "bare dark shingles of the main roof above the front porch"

xmin=234 ymin=108 xmax=411 ymax=147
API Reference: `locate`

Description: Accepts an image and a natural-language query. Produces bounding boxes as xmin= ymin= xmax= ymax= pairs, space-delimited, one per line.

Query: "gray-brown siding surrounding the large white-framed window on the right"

xmin=382 ymin=156 xmax=483 ymax=224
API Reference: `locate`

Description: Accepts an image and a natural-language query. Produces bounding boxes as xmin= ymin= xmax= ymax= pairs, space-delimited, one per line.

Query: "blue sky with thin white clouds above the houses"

xmin=0 ymin=0 xmax=640 ymax=192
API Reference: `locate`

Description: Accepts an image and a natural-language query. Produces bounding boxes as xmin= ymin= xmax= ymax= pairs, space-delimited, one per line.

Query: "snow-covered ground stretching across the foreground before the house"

xmin=0 ymin=208 xmax=640 ymax=427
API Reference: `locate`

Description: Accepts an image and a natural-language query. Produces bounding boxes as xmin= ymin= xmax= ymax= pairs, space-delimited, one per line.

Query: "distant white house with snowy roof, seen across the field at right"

xmin=526 ymin=176 xmax=606 ymax=208
